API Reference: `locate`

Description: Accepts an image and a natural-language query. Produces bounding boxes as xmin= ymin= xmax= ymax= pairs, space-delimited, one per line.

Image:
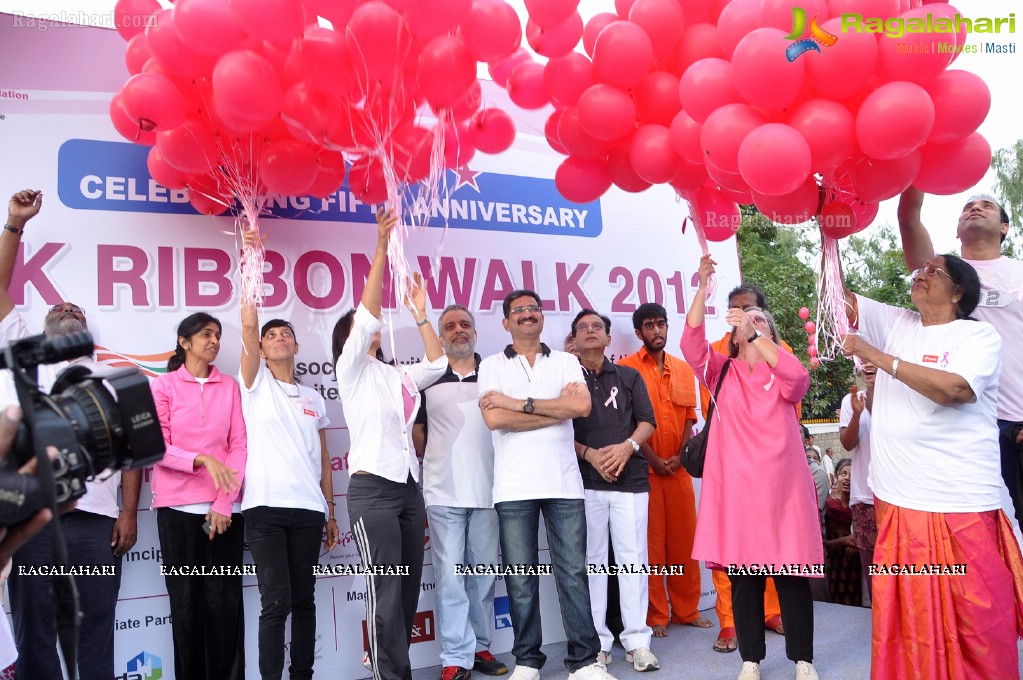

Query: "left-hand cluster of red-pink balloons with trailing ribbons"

xmin=109 ymin=0 xmax=522 ymax=214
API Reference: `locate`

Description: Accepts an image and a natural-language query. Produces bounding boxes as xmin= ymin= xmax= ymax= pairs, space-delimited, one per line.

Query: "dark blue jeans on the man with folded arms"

xmin=494 ymin=498 xmax=601 ymax=672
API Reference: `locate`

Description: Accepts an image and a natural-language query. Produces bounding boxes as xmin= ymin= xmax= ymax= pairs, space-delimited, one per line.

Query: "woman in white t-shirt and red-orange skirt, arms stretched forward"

xmin=845 ymin=255 xmax=1023 ymax=680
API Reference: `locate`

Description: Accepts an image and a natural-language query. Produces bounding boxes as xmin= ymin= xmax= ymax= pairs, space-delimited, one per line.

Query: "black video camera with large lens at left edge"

xmin=0 ymin=332 xmax=166 ymax=526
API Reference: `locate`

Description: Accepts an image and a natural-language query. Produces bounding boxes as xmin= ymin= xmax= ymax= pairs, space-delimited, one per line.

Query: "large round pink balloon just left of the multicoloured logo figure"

xmin=731 ymin=29 xmax=802 ymax=110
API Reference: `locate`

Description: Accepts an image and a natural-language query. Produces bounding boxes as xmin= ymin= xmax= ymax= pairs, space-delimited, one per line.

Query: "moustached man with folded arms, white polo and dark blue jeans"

xmin=478 ymin=290 xmax=612 ymax=680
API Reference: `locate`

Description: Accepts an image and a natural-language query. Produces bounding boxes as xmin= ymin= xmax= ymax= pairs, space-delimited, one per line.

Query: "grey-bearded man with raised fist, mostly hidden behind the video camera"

xmin=0 ymin=190 xmax=142 ymax=680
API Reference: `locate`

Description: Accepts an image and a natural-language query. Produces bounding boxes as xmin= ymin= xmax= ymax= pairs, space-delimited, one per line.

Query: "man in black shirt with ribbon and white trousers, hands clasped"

xmin=572 ymin=309 xmax=661 ymax=673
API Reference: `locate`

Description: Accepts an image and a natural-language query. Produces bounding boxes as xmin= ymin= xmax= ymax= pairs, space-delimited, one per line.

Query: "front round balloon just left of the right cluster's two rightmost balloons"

xmin=856 ymin=81 xmax=934 ymax=161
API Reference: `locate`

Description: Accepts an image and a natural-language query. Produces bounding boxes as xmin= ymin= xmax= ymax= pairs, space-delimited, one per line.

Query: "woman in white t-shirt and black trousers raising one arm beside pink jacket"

xmin=238 ymin=231 xmax=339 ymax=678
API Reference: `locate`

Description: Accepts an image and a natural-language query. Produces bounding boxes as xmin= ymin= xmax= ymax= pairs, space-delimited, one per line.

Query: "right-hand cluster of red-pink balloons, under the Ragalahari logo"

xmin=531 ymin=0 xmax=991 ymax=240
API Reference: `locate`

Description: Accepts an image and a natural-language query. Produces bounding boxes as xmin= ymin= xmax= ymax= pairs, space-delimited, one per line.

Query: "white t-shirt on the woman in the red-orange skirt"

xmin=856 ymin=296 xmax=1005 ymax=512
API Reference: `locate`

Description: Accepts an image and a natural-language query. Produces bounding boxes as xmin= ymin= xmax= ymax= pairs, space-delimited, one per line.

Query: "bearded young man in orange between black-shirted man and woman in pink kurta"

xmin=618 ymin=303 xmax=713 ymax=637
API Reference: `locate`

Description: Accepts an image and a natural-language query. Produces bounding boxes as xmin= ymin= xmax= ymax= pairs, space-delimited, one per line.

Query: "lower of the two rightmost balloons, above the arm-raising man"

xmin=913 ymin=132 xmax=991 ymax=195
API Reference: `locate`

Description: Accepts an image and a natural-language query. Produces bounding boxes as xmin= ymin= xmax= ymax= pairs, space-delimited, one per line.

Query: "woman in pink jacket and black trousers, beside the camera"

xmin=152 ymin=312 xmax=246 ymax=680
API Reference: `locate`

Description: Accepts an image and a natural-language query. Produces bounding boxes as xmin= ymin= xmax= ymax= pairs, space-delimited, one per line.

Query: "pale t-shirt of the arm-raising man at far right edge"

xmin=966 ymin=258 xmax=1023 ymax=421
